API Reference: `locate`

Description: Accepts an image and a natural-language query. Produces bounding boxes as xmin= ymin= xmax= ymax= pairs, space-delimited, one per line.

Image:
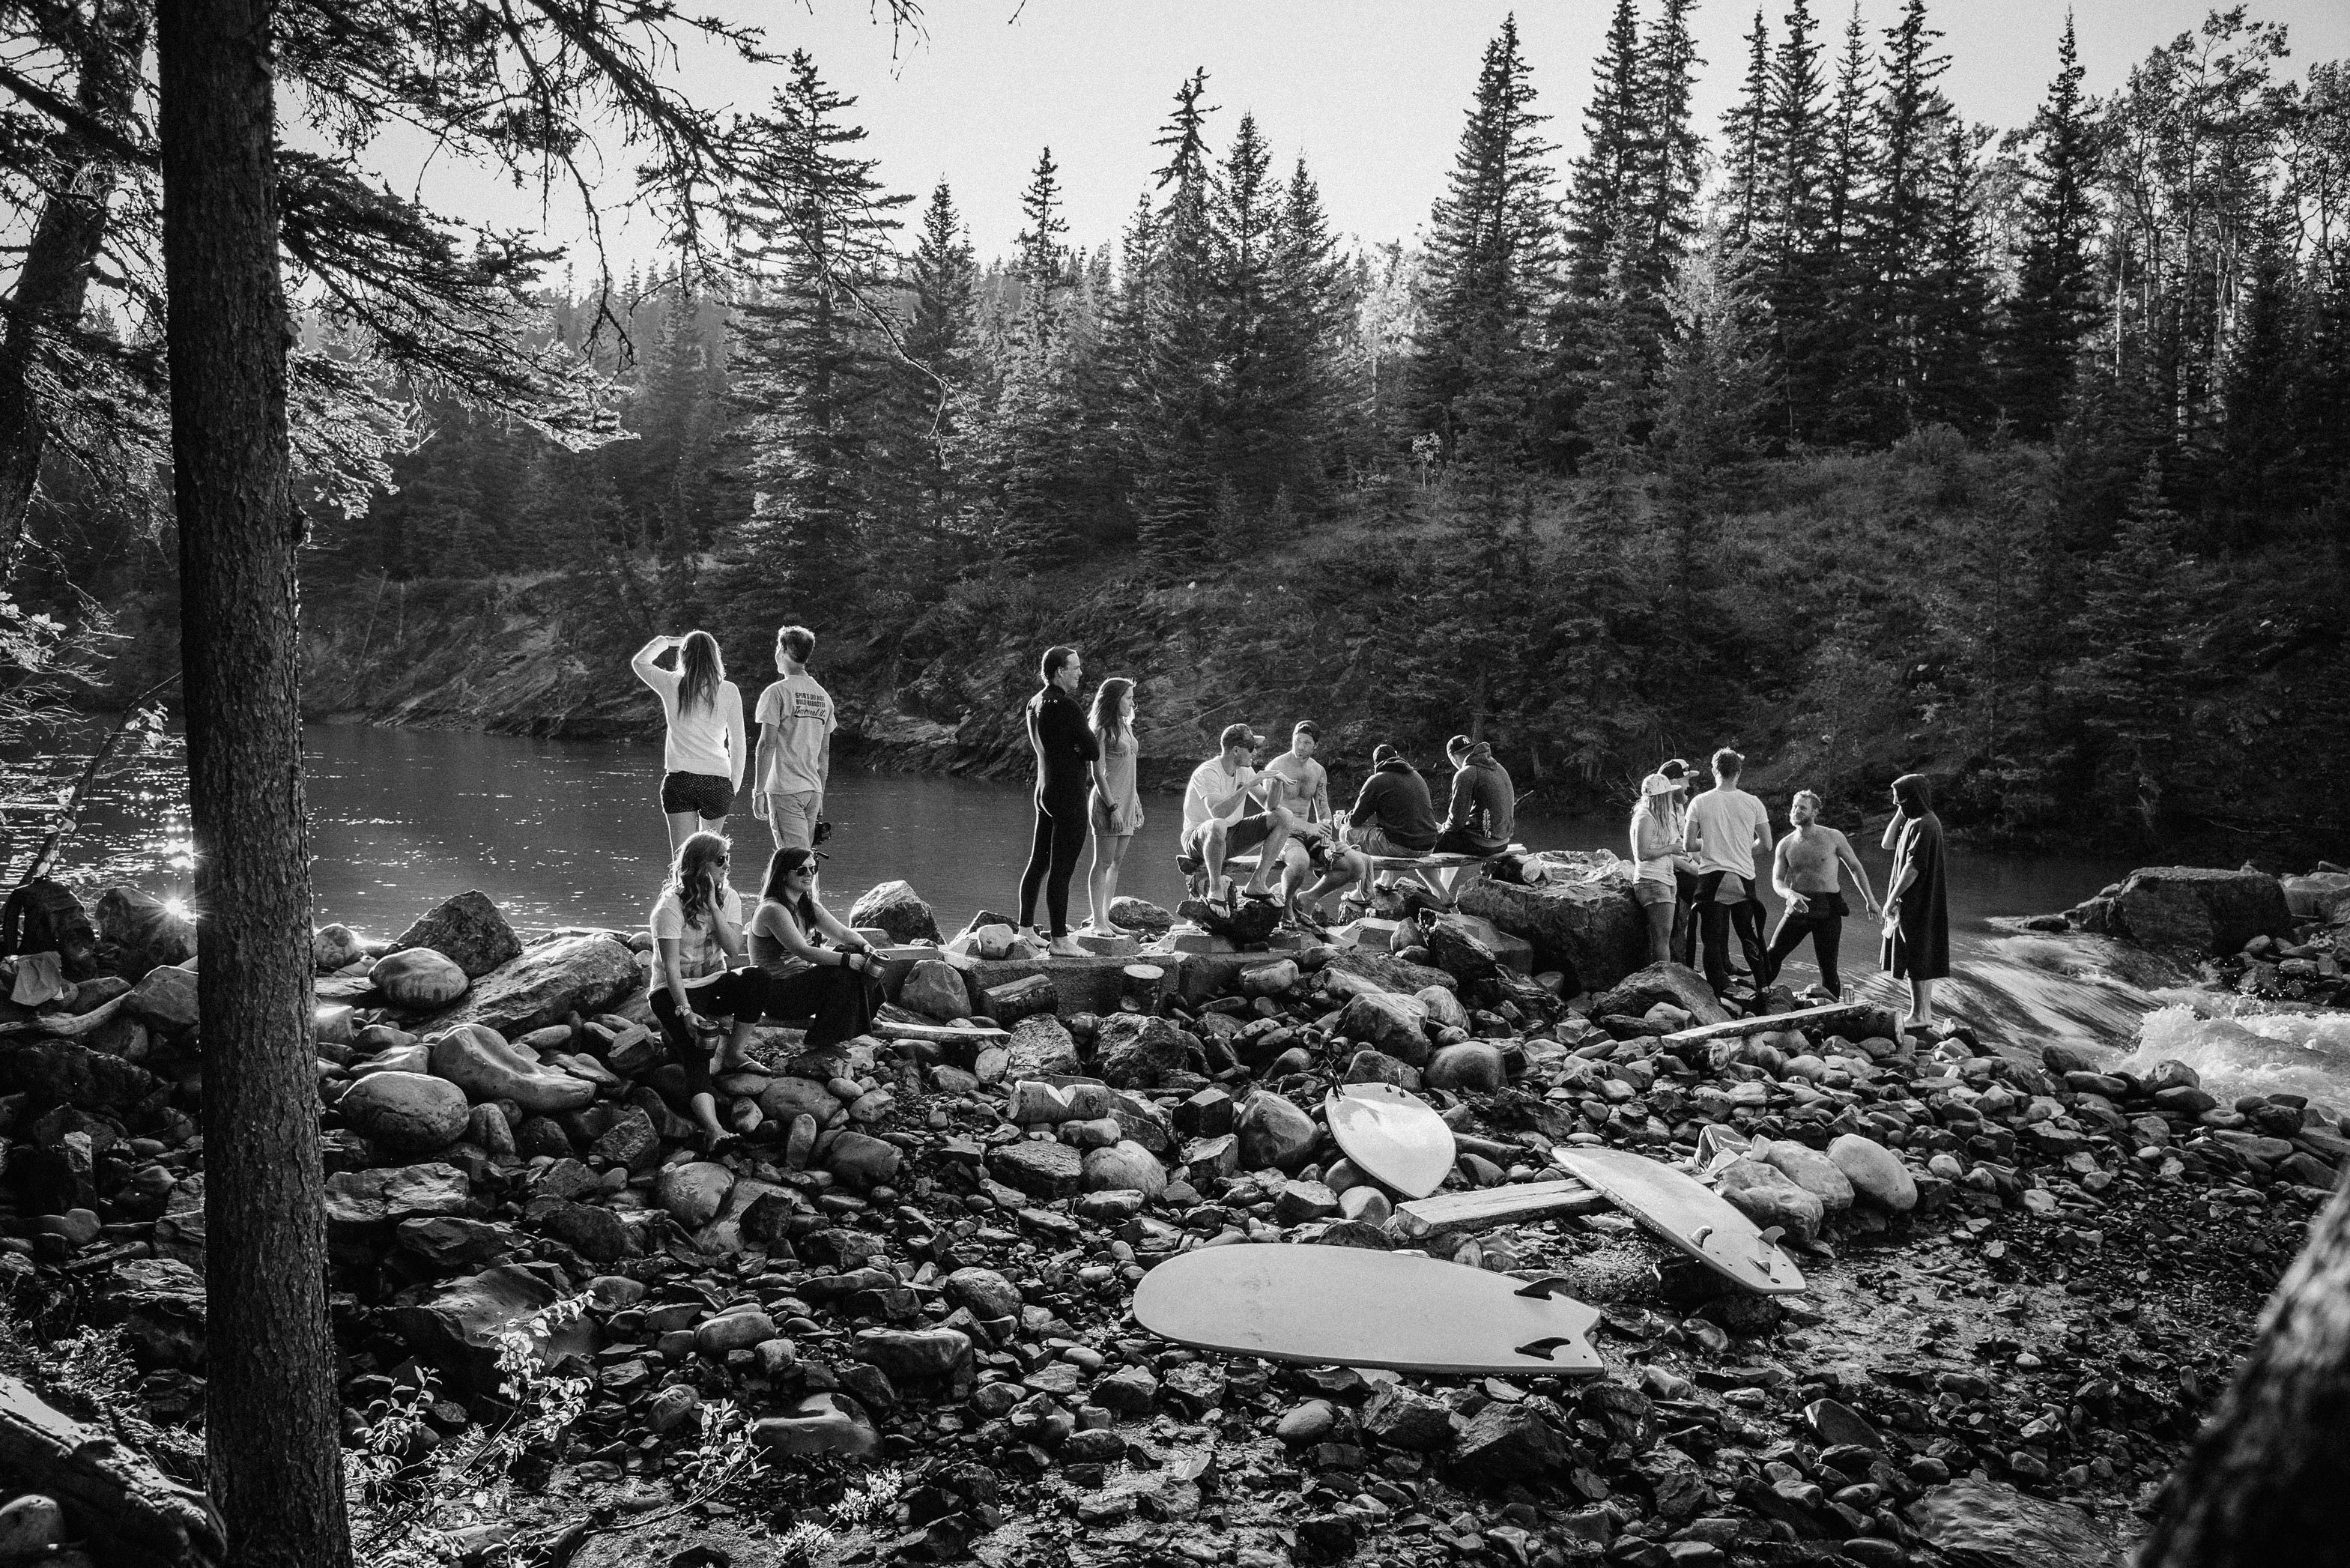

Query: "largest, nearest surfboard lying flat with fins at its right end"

xmin=1135 ymin=1244 xmax=1605 ymax=1378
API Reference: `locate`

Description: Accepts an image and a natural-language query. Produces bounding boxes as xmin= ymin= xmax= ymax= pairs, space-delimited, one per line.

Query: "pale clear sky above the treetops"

xmin=385 ymin=0 xmax=2350 ymax=279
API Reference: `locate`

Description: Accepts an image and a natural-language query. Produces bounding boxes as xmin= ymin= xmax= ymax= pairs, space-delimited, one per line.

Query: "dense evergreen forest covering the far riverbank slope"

xmin=19 ymin=0 xmax=2350 ymax=847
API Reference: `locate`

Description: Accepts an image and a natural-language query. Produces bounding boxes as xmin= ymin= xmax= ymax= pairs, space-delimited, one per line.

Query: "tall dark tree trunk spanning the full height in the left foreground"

xmin=157 ymin=0 xmax=350 ymax=1568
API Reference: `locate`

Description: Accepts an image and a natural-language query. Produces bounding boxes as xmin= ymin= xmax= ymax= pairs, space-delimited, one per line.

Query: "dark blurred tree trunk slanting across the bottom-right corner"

xmin=2139 ymin=1170 xmax=2350 ymax=1568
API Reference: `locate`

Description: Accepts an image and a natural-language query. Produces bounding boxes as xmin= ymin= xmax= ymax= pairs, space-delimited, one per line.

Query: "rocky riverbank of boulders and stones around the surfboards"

xmin=0 ymin=889 xmax=2350 ymax=1568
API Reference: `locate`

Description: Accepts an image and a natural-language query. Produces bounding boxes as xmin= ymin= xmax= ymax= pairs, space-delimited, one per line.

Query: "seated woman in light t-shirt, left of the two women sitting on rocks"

xmin=653 ymin=832 xmax=771 ymax=1145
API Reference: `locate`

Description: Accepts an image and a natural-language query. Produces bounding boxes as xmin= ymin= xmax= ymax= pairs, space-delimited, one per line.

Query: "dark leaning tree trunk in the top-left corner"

xmin=0 ymin=0 xmax=145 ymax=585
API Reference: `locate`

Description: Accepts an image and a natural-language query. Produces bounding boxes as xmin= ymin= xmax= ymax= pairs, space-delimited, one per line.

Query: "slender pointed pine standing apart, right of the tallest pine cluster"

xmin=2005 ymin=12 xmax=2096 ymax=440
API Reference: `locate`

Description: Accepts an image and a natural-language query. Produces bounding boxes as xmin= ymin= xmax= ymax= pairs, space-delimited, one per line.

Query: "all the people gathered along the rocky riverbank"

xmin=630 ymin=626 xmax=1951 ymax=1114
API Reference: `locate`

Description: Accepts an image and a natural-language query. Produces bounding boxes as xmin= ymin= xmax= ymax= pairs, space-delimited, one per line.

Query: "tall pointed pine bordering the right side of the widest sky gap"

xmin=1414 ymin=16 xmax=1558 ymax=461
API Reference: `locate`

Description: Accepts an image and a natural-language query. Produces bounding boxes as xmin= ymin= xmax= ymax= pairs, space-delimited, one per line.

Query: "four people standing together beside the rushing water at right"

xmin=1631 ymin=745 xmax=1951 ymax=1027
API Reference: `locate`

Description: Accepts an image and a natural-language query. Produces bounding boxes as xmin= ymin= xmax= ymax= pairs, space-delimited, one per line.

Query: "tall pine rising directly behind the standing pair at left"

xmin=736 ymin=49 xmax=912 ymax=609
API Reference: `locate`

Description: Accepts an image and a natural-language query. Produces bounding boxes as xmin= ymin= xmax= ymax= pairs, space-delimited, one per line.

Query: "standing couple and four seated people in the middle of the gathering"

xmin=1017 ymin=644 xmax=1518 ymax=957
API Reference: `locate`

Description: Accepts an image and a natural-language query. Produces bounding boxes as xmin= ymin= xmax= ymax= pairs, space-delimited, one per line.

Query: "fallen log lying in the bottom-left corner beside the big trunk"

xmin=0 ymin=1375 xmax=228 ymax=1568
